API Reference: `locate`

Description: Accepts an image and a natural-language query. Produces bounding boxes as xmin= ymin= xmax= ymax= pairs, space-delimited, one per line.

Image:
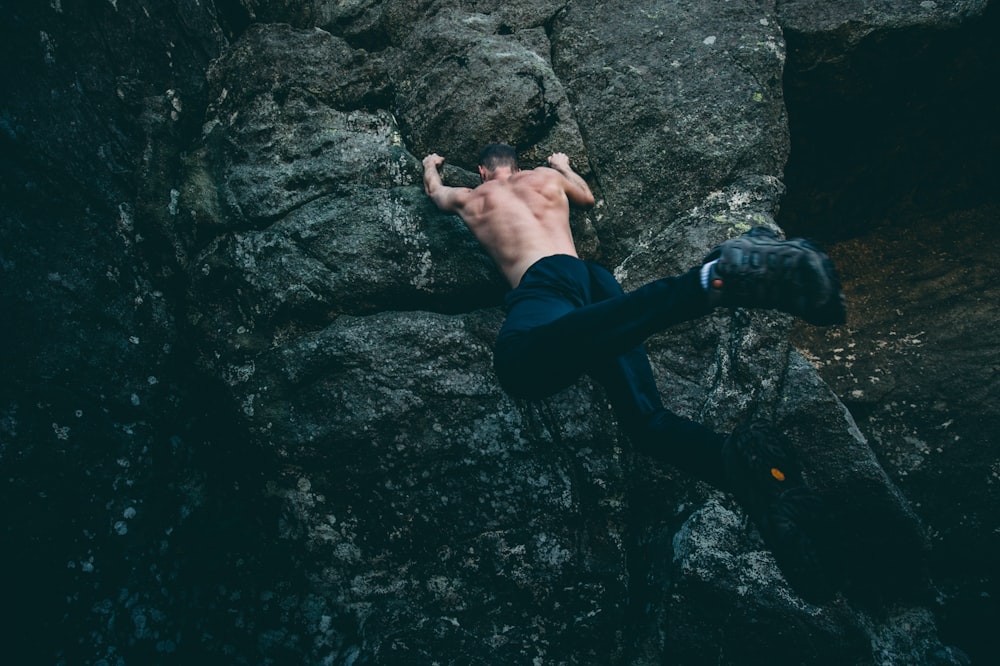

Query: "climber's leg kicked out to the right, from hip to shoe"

xmin=494 ymin=227 xmax=845 ymax=397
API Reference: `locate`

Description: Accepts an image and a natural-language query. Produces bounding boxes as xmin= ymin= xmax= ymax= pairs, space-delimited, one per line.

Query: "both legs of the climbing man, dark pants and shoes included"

xmin=495 ymin=229 xmax=846 ymax=600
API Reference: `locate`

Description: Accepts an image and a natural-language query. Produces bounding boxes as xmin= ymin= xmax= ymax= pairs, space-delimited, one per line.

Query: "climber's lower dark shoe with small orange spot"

xmin=722 ymin=422 xmax=833 ymax=601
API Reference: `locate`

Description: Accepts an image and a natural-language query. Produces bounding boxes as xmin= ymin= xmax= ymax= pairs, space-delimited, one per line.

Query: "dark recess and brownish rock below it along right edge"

xmin=779 ymin=3 xmax=1000 ymax=662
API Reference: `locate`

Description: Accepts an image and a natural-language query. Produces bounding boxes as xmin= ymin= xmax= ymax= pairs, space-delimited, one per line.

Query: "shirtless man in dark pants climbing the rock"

xmin=423 ymin=144 xmax=845 ymax=584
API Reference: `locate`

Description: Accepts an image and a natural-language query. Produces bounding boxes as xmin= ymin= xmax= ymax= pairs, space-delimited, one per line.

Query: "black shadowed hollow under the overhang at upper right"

xmin=778 ymin=4 xmax=1000 ymax=244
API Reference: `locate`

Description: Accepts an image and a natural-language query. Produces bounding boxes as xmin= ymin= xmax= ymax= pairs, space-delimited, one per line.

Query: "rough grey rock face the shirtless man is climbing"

xmin=0 ymin=0 xmax=996 ymax=665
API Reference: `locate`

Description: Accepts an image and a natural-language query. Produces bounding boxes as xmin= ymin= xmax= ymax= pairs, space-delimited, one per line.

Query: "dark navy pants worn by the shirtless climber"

xmin=494 ymin=255 xmax=723 ymax=482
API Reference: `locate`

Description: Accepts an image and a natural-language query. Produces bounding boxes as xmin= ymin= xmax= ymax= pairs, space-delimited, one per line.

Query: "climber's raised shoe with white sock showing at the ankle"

xmin=704 ymin=227 xmax=847 ymax=326
